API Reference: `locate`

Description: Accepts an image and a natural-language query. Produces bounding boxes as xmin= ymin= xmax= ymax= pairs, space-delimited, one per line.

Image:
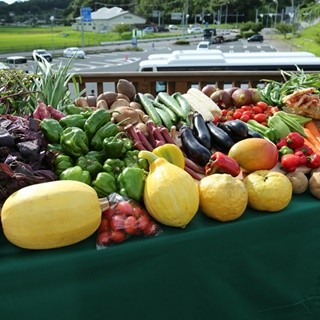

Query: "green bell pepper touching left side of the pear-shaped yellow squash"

xmin=117 ymin=167 xmax=146 ymax=201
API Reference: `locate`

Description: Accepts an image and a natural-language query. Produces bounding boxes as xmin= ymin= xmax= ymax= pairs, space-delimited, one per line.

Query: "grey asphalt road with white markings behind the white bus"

xmin=25 ymin=37 xmax=283 ymax=73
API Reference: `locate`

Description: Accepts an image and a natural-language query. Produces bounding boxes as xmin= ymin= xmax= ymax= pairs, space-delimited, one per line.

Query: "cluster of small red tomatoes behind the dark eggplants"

xmin=215 ymin=101 xmax=279 ymax=125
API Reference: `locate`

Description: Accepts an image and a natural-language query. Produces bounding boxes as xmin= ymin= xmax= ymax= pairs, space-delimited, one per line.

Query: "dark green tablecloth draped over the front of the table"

xmin=0 ymin=193 xmax=320 ymax=320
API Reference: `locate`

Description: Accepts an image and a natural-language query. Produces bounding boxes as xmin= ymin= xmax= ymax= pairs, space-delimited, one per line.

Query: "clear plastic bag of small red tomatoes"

xmin=96 ymin=193 xmax=162 ymax=250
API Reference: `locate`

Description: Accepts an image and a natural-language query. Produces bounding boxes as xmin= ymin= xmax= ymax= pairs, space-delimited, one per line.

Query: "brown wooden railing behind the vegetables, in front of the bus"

xmin=69 ymin=71 xmax=283 ymax=95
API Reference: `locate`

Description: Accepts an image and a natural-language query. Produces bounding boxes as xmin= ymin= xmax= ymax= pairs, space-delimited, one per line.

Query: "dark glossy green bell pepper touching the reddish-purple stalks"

xmin=103 ymin=132 xmax=133 ymax=159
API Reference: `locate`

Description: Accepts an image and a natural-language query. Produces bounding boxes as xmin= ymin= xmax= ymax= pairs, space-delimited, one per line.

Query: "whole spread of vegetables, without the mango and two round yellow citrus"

xmin=0 ymin=61 xmax=320 ymax=249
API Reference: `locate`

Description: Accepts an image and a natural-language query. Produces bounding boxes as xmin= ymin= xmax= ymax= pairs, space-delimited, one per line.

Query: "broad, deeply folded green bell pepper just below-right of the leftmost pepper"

xmin=60 ymin=127 xmax=89 ymax=158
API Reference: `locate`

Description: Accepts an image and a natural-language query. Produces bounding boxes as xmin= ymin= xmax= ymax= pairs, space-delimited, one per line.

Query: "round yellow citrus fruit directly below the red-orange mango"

xmin=243 ymin=170 xmax=292 ymax=212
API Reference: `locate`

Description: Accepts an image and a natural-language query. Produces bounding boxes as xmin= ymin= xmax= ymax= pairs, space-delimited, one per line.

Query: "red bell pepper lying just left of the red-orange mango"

xmin=205 ymin=151 xmax=241 ymax=177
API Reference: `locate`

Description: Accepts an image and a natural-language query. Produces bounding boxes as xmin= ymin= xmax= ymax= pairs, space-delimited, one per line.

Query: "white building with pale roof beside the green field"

xmin=72 ymin=7 xmax=146 ymax=33
